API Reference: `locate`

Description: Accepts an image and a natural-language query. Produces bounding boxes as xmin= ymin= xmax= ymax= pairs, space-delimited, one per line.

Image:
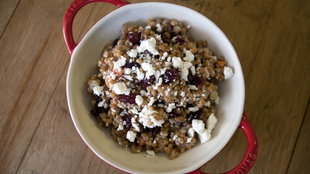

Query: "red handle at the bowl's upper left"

xmin=62 ymin=0 xmax=129 ymax=54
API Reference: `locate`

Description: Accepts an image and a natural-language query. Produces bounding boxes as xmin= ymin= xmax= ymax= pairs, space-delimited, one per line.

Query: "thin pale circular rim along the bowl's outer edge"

xmin=66 ymin=2 xmax=245 ymax=173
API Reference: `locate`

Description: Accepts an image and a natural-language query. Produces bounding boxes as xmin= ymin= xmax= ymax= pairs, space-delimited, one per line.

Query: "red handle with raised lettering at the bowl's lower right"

xmin=188 ymin=113 xmax=258 ymax=174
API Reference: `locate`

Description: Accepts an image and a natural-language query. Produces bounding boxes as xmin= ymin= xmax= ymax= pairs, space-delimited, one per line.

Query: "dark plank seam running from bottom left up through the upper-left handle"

xmin=14 ymin=6 xmax=95 ymax=174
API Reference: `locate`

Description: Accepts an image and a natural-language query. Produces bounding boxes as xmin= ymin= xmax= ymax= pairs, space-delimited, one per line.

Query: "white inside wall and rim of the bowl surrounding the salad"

xmin=67 ymin=3 xmax=244 ymax=173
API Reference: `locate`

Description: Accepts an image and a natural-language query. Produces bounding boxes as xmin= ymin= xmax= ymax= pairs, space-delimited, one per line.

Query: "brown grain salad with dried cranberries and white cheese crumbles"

xmin=88 ymin=18 xmax=233 ymax=159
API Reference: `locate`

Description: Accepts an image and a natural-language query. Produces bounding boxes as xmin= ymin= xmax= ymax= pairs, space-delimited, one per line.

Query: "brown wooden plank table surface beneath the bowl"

xmin=0 ymin=0 xmax=310 ymax=174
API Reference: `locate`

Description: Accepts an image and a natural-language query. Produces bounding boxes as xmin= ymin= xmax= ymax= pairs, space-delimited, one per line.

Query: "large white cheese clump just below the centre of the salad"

xmin=139 ymin=106 xmax=165 ymax=128
